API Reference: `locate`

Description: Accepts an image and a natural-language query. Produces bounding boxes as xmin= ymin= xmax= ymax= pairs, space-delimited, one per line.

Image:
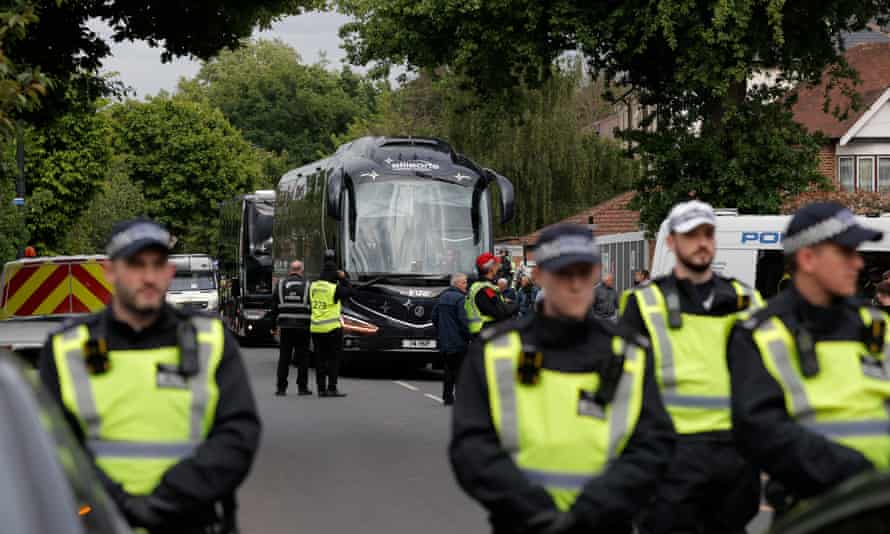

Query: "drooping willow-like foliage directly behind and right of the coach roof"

xmin=344 ymin=65 xmax=640 ymax=235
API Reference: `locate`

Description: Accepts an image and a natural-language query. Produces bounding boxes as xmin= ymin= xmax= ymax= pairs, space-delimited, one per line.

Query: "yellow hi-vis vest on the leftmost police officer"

xmin=51 ymin=317 xmax=225 ymax=495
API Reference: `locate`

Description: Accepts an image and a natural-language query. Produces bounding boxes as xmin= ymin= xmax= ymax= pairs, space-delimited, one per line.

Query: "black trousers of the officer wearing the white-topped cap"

xmin=640 ymin=433 xmax=761 ymax=534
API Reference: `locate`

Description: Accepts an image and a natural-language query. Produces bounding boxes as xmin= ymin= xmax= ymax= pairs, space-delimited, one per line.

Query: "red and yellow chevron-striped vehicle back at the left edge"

xmin=0 ymin=261 xmax=111 ymax=317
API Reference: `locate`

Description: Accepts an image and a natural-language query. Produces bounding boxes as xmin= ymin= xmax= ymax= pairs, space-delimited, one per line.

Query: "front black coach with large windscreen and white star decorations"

xmin=273 ymin=137 xmax=513 ymax=365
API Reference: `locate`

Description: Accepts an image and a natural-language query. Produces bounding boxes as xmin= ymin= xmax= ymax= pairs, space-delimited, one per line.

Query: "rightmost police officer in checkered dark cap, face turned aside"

xmin=729 ymin=202 xmax=890 ymax=513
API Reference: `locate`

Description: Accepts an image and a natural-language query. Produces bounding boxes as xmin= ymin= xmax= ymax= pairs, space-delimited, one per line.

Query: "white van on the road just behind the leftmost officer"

xmin=167 ymin=254 xmax=219 ymax=312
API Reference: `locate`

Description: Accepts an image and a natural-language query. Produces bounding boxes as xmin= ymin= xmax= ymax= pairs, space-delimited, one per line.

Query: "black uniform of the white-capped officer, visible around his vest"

xmin=619 ymin=274 xmax=760 ymax=534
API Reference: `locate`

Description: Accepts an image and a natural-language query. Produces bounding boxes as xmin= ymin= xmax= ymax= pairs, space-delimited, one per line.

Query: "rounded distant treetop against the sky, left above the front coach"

xmin=179 ymin=40 xmax=377 ymax=168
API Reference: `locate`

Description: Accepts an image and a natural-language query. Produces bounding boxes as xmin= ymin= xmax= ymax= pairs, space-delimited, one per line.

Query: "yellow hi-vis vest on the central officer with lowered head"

xmin=484 ymin=331 xmax=646 ymax=510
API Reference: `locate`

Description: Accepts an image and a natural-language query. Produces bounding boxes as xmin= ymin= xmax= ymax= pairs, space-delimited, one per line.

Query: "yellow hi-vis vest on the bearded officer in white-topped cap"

xmin=621 ymin=280 xmax=763 ymax=434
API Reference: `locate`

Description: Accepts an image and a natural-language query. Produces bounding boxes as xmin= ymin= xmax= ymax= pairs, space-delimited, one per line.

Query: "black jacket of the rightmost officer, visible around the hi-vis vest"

xmin=729 ymin=285 xmax=874 ymax=512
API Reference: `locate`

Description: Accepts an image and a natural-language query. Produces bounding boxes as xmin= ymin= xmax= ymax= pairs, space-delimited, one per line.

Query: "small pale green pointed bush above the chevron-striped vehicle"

xmin=62 ymin=156 xmax=145 ymax=255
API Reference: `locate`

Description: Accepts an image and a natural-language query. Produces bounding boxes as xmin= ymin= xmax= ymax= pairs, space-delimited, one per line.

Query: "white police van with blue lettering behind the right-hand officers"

xmin=651 ymin=209 xmax=890 ymax=298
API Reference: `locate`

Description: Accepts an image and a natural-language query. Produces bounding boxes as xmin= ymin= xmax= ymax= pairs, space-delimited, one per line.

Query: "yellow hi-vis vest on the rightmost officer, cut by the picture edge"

xmin=754 ymin=308 xmax=890 ymax=469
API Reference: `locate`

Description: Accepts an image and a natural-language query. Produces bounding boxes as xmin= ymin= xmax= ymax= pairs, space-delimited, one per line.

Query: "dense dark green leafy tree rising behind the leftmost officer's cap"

xmin=109 ymin=97 xmax=263 ymax=252
